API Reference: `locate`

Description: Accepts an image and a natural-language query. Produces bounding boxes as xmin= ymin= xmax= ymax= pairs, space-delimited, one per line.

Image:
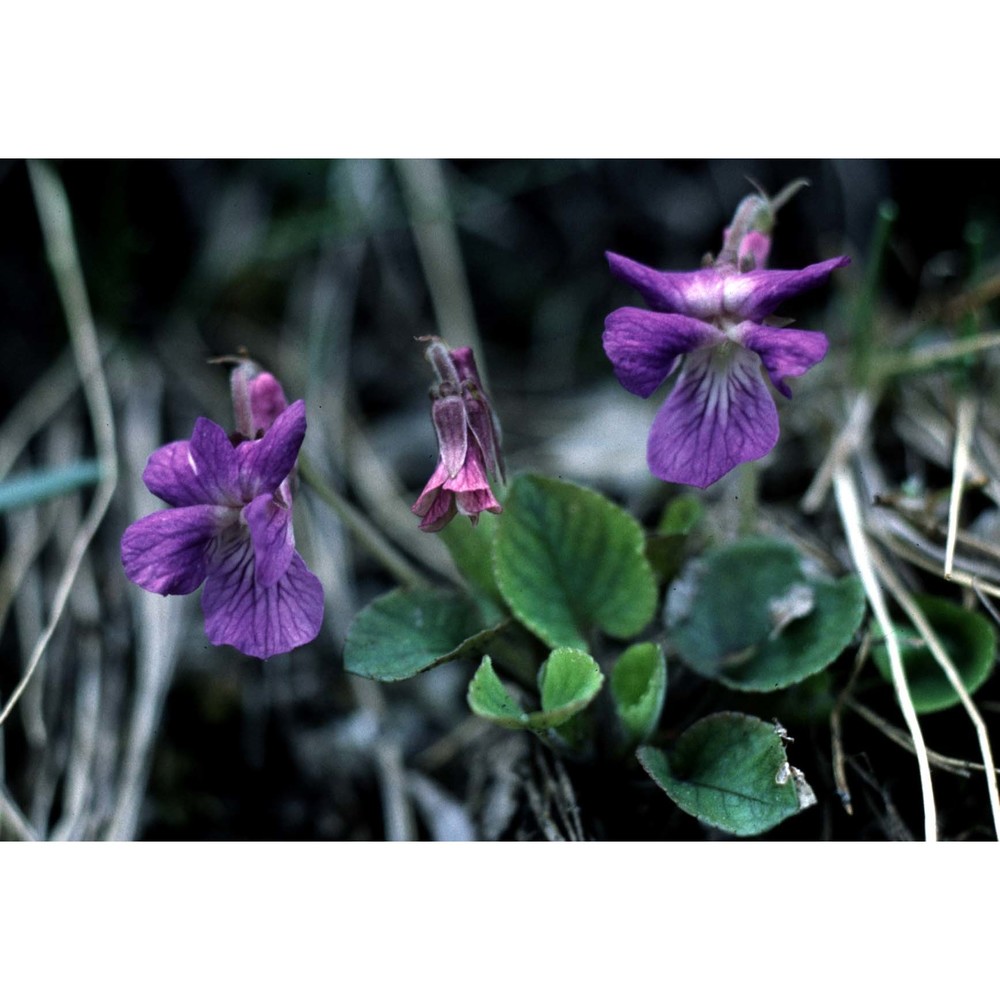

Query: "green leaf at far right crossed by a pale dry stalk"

xmin=873 ymin=596 xmax=997 ymax=715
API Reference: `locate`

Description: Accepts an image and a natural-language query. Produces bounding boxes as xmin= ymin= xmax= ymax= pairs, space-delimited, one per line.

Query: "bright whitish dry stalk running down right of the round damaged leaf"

xmin=833 ymin=466 xmax=937 ymax=841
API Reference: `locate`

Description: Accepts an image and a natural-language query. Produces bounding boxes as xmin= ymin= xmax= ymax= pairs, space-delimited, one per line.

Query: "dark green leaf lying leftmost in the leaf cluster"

xmin=344 ymin=590 xmax=503 ymax=681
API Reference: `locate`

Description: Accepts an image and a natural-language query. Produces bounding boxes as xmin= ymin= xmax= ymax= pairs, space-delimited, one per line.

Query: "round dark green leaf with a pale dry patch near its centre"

xmin=666 ymin=538 xmax=865 ymax=691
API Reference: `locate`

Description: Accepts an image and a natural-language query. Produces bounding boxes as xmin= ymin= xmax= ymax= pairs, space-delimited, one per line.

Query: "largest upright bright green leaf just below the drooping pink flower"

xmin=493 ymin=475 xmax=656 ymax=650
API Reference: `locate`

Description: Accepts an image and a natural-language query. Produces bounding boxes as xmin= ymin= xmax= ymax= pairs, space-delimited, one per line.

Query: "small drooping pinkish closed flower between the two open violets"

xmin=411 ymin=337 xmax=504 ymax=531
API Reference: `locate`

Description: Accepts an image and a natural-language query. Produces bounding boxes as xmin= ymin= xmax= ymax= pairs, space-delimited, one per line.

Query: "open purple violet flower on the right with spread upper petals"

xmin=604 ymin=195 xmax=850 ymax=487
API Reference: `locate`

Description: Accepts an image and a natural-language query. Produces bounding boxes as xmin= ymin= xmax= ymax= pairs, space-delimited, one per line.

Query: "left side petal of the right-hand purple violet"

xmin=604 ymin=306 xmax=725 ymax=399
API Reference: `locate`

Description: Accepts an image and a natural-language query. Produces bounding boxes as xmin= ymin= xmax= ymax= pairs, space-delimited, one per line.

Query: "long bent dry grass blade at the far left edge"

xmin=0 ymin=163 xmax=117 ymax=725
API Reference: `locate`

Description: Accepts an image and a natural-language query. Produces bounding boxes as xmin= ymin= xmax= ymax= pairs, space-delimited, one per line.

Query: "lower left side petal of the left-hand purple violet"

xmin=122 ymin=504 xmax=237 ymax=594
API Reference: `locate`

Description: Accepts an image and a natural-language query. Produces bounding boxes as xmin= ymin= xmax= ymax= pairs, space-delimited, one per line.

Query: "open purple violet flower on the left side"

xmin=122 ymin=362 xmax=323 ymax=659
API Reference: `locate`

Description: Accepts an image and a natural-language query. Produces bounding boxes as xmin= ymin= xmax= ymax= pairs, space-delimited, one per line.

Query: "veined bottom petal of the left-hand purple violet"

xmin=201 ymin=535 xmax=323 ymax=660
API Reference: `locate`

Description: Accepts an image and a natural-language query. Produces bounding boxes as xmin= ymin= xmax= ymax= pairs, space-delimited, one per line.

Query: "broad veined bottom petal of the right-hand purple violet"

xmin=647 ymin=344 xmax=778 ymax=487
